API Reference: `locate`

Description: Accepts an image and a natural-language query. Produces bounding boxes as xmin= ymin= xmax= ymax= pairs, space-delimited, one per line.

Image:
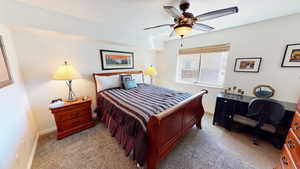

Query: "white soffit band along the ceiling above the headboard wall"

xmin=0 ymin=0 xmax=155 ymax=48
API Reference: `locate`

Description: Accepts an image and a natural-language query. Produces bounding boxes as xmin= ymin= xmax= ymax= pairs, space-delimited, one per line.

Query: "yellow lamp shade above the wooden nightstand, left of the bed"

xmin=53 ymin=62 xmax=81 ymax=80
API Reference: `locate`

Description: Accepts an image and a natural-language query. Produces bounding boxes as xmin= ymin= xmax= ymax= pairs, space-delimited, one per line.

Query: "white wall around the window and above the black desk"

xmin=157 ymin=14 xmax=300 ymax=112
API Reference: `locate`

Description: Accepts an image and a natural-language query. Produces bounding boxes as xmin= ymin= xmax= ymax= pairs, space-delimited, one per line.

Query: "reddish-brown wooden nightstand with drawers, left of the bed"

xmin=50 ymin=98 xmax=95 ymax=140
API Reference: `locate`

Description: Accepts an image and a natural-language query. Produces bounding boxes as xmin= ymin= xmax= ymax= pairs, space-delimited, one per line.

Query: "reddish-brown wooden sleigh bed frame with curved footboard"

xmin=93 ymin=71 xmax=207 ymax=169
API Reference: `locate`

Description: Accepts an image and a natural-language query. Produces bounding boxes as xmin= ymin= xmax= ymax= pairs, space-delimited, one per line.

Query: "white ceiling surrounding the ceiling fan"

xmin=18 ymin=0 xmax=300 ymax=47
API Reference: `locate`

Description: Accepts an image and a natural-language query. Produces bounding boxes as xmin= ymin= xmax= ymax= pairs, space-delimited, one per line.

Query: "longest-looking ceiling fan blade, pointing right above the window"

xmin=196 ymin=7 xmax=239 ymax=21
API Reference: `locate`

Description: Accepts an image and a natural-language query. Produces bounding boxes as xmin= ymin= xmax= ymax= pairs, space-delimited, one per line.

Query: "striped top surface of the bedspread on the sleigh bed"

xmin=100 ymin=84 xmax=192 ymax=130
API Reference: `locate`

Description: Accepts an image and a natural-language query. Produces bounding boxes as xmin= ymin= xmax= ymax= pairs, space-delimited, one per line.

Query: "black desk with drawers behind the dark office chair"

xmin=213 ymin=92 xmax=296 ymax=148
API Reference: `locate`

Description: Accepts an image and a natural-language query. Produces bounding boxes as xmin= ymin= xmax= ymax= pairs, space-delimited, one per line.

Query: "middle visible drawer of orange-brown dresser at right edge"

xmin=285 ymin=129 xmax=300 ymax=168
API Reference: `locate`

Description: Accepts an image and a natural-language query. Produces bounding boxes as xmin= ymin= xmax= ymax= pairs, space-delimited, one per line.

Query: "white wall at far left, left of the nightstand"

xmin=0 ymin=25 xmax=37 ymax=169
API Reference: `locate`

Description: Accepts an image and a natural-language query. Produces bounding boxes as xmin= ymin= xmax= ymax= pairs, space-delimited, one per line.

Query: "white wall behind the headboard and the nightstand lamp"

xmin=12 ymin=28 xmax=155 ymax=130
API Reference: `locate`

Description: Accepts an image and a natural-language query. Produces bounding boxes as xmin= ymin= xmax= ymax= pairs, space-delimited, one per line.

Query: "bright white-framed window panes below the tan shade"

xmin=177 ymin=51 xmax=228 ymax=87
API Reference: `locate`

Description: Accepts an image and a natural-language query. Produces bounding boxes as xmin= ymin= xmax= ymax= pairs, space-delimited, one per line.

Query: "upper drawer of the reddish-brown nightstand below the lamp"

xmin=55 ymin=107 xmax=91 ymax=122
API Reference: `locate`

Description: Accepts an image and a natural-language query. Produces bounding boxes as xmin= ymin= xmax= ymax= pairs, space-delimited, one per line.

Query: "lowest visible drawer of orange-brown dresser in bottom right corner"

xmin=280 ymin=144 xmax=297 ymax=169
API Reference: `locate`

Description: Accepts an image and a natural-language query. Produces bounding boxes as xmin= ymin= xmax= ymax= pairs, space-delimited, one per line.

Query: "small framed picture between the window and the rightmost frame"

xmin=234 ymin=57 xmax=262 ymax=73
